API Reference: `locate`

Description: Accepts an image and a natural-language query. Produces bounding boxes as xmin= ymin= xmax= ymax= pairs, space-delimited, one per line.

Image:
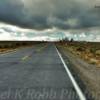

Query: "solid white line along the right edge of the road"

xmin=56 ymin=48 xmax=86 ymax=100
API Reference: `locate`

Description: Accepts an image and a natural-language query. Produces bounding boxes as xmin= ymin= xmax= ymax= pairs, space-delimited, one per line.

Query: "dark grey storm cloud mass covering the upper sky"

xmin=0 ymin=0 xmax=100 ymax=30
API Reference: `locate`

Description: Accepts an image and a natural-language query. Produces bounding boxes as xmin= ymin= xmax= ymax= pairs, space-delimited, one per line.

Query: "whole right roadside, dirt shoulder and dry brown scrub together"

xmin=57 ymin=42 xmax=100 ymax=100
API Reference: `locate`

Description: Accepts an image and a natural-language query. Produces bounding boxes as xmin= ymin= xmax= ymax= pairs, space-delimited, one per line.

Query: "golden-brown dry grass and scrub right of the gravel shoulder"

xmin=58 ymin=42 xmax=100 ymax=67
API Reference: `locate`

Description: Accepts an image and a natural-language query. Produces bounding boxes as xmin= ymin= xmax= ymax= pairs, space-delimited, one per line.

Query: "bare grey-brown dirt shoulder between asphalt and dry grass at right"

xmin=56 ymin=47 xmax=100 ymax=100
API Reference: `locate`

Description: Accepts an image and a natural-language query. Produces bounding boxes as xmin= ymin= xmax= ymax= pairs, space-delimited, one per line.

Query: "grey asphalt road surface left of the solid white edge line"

xmin=0 ymin=43 xmax=84 ymax=100
